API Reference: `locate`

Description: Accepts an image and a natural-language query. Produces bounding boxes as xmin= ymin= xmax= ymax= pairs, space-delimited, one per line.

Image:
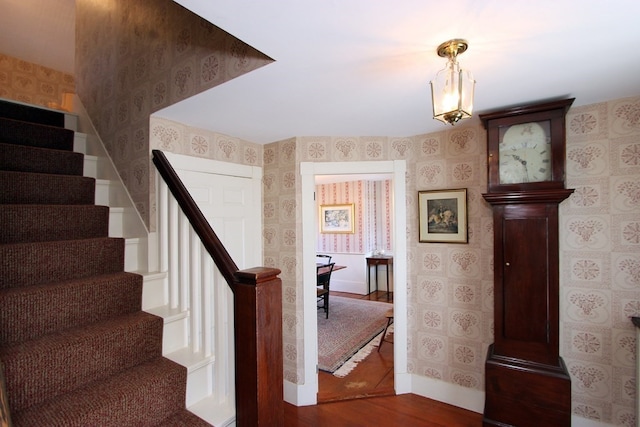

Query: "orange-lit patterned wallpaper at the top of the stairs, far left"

xmin=0 ymin=53 xmax=75 ymax=109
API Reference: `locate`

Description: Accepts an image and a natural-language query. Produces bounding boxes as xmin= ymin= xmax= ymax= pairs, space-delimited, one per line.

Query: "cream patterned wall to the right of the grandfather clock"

xmin=560 ymin=97 xmax=640 ymax=425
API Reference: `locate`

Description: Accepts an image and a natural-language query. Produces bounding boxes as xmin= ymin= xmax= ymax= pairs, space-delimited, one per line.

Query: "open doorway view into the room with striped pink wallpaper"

xmin=315 ymin=174 xmax=395 ymax=403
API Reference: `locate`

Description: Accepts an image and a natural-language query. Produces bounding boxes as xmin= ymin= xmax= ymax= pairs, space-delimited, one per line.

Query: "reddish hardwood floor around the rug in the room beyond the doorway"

xmin=318 ymin=291 xmax=395 ymax=403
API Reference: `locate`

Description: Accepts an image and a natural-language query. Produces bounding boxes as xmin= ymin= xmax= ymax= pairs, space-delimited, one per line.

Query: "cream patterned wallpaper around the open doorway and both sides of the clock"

xmin=264 ymin=97 xmax=640 ymax=426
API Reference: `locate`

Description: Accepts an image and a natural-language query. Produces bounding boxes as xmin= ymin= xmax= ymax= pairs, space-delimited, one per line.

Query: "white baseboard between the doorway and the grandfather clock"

xmin=411 ymin=374 xmax=485 ymax=414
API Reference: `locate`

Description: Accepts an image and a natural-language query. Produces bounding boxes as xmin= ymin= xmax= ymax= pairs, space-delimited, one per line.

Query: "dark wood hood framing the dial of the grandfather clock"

xmin=479 ymin=98 xmax=575 ymax=193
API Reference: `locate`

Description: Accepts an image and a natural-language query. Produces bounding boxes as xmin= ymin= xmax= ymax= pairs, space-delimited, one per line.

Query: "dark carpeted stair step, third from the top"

xmin=0 ymin=141 xmax=84 ymax=176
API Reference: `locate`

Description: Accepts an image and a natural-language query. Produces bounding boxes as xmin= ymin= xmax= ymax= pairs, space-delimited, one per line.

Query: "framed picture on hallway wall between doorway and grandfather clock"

xmin=418 ymin=188 xmax=468 ymax=243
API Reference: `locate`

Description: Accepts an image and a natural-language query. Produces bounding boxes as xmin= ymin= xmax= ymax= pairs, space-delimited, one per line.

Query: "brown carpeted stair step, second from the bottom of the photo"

xmin=0 ymin=311 xmax=162 ymax=411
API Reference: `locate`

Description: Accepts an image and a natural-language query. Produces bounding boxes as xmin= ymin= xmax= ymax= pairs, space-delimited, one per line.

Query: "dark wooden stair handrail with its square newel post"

xmin=152 ymin=150 xmax=284 ymax=427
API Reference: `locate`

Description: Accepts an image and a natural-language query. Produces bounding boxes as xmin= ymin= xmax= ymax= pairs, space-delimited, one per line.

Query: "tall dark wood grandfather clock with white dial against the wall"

xmin=480 ymin=99 xmax=573 ymax=427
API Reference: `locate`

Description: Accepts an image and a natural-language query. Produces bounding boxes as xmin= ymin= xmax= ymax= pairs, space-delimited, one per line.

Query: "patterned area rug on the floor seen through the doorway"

xmin=318 ymin=296 xmax=393 ymax=372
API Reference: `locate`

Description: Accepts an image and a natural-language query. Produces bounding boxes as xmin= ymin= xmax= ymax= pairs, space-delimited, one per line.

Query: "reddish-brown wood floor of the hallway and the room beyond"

xmin=285 ymin=292 xmax=482 ymax=427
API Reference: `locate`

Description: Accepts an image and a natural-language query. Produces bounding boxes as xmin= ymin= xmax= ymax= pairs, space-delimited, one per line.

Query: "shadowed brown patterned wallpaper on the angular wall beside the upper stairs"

xmin=76 ymin=0 xmax=271 ymax=225
